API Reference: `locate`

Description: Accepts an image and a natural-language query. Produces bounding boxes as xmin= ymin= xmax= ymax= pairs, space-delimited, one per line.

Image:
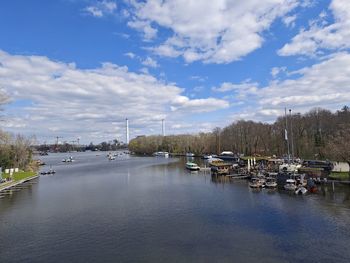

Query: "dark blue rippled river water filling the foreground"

xmin=0 ymin=152 xmax=350 ymax=262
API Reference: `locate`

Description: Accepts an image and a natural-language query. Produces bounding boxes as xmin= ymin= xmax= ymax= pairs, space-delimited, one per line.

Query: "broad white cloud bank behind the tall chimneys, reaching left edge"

xmin=0 ymin=51 xmax=228 ymax=142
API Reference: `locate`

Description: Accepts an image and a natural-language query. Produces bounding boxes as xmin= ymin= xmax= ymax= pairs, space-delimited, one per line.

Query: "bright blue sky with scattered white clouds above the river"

xmin=0 ymin=0 xmax=350 ymax=143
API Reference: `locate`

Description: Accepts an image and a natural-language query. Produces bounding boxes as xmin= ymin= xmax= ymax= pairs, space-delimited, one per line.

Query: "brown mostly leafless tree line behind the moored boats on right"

xmin=129 ymin=106 xmax=350 ymax=164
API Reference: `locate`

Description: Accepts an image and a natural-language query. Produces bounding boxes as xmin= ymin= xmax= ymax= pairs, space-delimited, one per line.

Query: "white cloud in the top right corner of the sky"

xmin=278 ymin=0 xmax=350 ymax=56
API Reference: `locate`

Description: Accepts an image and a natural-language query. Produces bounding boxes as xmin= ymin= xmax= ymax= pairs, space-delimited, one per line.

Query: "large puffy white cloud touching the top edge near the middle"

xmin=128 ymin=0 xmax=304 ymax=63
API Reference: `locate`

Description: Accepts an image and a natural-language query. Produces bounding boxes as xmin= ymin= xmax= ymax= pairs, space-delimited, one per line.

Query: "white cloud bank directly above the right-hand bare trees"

xmin=224 ymin=53 xmax=350 ymax=121
